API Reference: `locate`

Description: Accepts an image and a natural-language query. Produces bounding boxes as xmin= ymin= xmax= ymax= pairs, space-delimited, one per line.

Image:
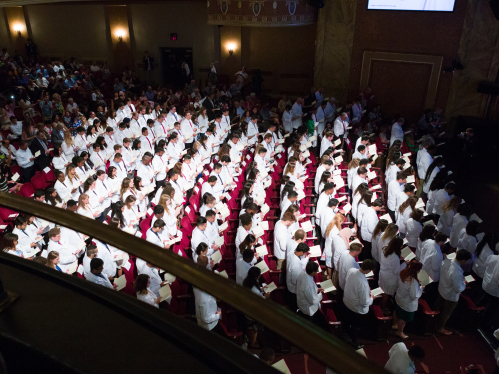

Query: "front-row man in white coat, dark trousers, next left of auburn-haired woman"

xmin=342 ymin=260 xmax=376 ymax=349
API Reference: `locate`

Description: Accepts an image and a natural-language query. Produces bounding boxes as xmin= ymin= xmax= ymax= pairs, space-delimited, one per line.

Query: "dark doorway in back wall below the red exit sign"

xmin=160 ymin=48 xmax=193 ymax=88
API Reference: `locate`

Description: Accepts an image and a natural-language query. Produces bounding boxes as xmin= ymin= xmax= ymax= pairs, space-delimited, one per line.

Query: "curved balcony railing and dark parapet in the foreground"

xmin=0 ymin=192 xmax=386 ymax=374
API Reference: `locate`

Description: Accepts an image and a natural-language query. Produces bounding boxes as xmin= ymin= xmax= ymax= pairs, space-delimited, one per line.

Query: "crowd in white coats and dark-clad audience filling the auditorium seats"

xmin=0 ymin=48 xmax=499 ymax=373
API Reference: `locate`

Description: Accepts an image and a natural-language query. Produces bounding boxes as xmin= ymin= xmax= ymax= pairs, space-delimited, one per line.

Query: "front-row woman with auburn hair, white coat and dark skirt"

xmin=393 ymin=260 xmax=423 ymax=339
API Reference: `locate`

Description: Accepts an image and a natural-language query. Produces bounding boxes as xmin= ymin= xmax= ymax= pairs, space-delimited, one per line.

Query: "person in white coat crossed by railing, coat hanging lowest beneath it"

xmin=192 ymin=256 xmax=225 ymax=337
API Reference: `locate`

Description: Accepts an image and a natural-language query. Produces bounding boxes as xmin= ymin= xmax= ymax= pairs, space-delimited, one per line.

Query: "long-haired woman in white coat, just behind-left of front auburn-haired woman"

xmin=379 ymin=238 xmax=405 ymax=314
